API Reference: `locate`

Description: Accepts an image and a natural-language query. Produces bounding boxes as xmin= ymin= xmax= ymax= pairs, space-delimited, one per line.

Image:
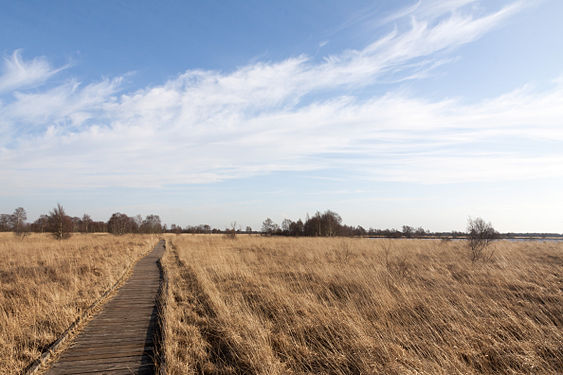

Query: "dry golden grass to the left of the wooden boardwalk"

xmin=0 ymin=233 xmax=156 ymax=374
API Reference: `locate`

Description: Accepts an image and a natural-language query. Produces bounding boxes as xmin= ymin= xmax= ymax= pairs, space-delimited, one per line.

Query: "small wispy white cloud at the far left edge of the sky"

xmin=0 ymin=50 xmax=66 ymax=93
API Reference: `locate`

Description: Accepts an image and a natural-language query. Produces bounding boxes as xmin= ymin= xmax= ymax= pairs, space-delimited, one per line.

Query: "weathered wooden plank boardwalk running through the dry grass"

xmin=47 ymin=241 xmax=164 ymax=375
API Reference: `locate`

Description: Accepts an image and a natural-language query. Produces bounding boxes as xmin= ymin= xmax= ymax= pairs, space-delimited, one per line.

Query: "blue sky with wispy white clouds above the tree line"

xmin=0 ymin=0 xmax=563 ymax=233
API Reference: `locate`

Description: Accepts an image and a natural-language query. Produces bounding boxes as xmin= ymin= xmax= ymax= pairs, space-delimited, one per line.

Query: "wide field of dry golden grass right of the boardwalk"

xmin=163 ymin=235 xmax=563 ymax=374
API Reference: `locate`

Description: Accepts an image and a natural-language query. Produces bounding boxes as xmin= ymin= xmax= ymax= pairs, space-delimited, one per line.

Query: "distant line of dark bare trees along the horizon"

xmin=0 ymin=204 xmax=563 ymax=239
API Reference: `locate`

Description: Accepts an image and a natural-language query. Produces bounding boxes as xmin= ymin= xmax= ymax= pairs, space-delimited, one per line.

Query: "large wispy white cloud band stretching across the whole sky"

xmin=0 ymin=1 xmax=563 ymax=191
